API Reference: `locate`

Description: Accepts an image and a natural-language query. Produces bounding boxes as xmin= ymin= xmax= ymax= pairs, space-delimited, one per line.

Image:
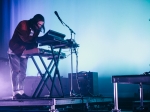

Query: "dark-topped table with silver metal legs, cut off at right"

xmin=112 ymin=74 xmax=150 ymax=112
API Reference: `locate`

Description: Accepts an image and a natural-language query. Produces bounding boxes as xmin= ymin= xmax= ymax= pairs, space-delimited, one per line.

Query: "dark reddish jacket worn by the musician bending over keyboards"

xmin=9 ymin=20 xmax=40 ymax=56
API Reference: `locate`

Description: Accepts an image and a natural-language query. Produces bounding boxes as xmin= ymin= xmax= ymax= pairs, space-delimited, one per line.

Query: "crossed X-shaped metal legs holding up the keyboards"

xmin=30 ymin=49 xmax=64 ymax=98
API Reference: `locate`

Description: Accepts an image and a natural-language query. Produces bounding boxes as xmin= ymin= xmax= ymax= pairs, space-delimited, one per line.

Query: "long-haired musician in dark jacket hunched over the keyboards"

xmin=8 ymin=14 xmax=45 ymax=99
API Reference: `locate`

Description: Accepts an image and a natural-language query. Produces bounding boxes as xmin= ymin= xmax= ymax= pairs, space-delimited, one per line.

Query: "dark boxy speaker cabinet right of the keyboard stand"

xmin=68 ymin=72 xmax=99 ymax=96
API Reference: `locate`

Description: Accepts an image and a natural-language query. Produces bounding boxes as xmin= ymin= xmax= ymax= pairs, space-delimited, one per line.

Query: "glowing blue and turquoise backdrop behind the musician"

xmin=1 ymin=0 xmax=150 ymax=97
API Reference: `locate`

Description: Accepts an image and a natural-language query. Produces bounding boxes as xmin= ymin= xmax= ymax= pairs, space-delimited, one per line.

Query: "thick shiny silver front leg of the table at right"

xmin=112 ymin=83 xmax=121 ymax=112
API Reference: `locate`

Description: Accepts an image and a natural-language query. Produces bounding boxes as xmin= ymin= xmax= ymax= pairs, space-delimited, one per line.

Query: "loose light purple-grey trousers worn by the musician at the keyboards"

xmin=9 ymin=54 xmax=28 ymax=92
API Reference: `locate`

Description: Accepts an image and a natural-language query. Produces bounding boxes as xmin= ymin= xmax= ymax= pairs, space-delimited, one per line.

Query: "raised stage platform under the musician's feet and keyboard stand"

xmin=0 ymin=97 xmax=113 ymax=111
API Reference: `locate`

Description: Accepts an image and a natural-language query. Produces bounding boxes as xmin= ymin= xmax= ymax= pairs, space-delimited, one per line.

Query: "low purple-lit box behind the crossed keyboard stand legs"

xmin=24 ymin=76 xmax=69 ymax=97
